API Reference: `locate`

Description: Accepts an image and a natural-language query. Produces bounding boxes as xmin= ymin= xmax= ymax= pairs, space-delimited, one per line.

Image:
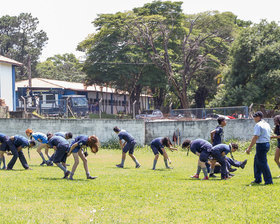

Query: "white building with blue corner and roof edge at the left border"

xmin=0 ymin=55 xmax=22 ymax=111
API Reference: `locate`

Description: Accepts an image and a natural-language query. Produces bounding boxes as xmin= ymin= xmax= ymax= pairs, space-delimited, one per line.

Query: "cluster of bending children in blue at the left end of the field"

xmin=0 ymin=129 xmax=99 ymax=180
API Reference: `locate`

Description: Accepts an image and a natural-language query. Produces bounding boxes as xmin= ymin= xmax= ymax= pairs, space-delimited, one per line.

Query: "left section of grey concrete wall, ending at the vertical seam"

xmin=0 ymin=118 xmax=145 ymax=144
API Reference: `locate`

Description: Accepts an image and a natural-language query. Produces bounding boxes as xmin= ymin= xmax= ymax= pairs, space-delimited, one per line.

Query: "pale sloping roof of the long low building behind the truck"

xmin=16 ymin=78 xmax=151 ymax=96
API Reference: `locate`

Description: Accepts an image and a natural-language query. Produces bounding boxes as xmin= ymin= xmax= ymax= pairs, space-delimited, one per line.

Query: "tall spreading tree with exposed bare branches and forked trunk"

xmin=122 ymin=1 xmax=237 ymax=108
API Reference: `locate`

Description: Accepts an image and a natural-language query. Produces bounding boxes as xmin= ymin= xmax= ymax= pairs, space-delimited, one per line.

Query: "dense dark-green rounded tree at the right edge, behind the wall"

xmin=211 ymin=20 xmax=280 ymax=106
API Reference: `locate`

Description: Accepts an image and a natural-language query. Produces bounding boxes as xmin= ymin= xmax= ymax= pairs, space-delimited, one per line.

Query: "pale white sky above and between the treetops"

xmin=0 ymin=0 xmax=280 ymax=61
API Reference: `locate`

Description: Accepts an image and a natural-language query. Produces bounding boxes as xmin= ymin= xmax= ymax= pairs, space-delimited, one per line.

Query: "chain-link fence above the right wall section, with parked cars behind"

xmin=170 ymin=106 xmax=249 ymax=119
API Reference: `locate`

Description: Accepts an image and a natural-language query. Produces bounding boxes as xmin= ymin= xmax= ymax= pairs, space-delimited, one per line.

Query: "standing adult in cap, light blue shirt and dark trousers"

xmin=246 ymin=111 xmax=273 ymax=184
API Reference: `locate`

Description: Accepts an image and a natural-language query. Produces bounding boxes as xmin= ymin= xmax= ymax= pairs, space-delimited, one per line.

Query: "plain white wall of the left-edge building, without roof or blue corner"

xmin=0 ymin=63 xmax=14 ymax=111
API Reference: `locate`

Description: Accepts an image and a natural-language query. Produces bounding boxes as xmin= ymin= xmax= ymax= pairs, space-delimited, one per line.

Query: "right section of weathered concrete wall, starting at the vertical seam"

xmin=145 ymin=119 xmax=274 ymax=144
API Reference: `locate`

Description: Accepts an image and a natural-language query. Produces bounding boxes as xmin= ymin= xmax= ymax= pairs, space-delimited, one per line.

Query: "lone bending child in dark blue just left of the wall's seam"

xmin=113 ymin=127 xmax=141 ymax=168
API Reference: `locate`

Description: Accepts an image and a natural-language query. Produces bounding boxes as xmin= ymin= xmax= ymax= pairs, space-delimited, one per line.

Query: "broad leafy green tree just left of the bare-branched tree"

xmin=78 ymin=13 xmax=166 ymax=111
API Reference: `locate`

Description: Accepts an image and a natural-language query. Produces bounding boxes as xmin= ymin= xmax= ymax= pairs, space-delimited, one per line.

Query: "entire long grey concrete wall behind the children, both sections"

xmin=0 ymin=119 xmax=274 ymax=145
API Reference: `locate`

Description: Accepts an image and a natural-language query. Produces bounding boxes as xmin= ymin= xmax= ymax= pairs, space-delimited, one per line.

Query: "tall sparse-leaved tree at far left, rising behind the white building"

xmin=0 ymin=13 xmax=48 ymax=79
